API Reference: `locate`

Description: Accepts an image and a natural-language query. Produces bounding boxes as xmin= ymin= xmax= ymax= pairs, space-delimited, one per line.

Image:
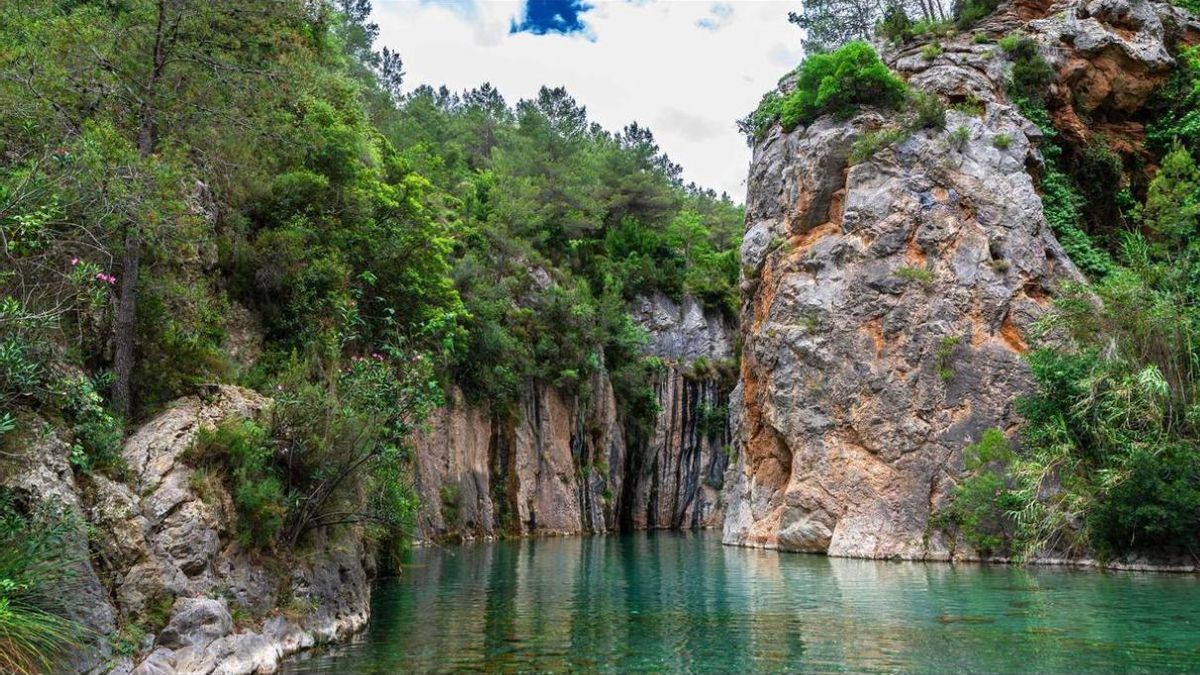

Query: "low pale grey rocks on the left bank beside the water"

xmin=0 ymin=387 xmax=371 ymax=675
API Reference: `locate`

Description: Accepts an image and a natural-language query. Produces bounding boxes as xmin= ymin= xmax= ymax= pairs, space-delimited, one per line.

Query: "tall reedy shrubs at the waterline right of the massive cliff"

xmin=955 ymin=149 xmax=1200 ymax=556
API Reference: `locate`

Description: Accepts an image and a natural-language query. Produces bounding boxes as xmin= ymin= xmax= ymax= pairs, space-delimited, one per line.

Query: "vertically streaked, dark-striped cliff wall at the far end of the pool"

xmin=415 ymin=295 xmax=733 ymax=539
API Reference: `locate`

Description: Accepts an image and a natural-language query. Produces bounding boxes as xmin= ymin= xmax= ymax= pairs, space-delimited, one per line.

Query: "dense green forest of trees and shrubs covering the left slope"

xmin=0 ymin=0 xmax=742 ymax=659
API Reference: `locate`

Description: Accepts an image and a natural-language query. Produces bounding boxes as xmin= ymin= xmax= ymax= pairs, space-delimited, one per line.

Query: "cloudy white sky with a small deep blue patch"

xmin=372 ymin=0 xmax=802 ymax=202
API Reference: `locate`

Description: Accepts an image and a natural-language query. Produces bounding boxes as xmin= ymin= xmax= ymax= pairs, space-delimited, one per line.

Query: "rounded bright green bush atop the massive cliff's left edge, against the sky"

xmin=744 ymin=42 xmax=907 ymax=131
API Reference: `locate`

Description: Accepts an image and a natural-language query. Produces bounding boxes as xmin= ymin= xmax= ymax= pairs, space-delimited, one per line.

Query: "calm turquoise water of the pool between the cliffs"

xmin=283 ymin=532 xmax=1200 ymax=674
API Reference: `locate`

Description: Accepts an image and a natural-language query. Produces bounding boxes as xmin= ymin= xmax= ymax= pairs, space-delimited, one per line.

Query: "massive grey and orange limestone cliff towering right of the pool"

xmin=724 ymin=0 xmax=1190 ymax=560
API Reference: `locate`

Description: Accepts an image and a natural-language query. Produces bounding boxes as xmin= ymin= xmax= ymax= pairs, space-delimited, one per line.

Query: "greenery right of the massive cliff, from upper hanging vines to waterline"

xmin=943 ymin=36 xmax=1200 ymax=557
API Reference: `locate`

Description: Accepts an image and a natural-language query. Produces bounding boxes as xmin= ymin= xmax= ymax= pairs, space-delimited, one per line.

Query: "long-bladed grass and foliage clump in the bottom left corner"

xmin=0 ymin=490 xmax=84 ymax=675
